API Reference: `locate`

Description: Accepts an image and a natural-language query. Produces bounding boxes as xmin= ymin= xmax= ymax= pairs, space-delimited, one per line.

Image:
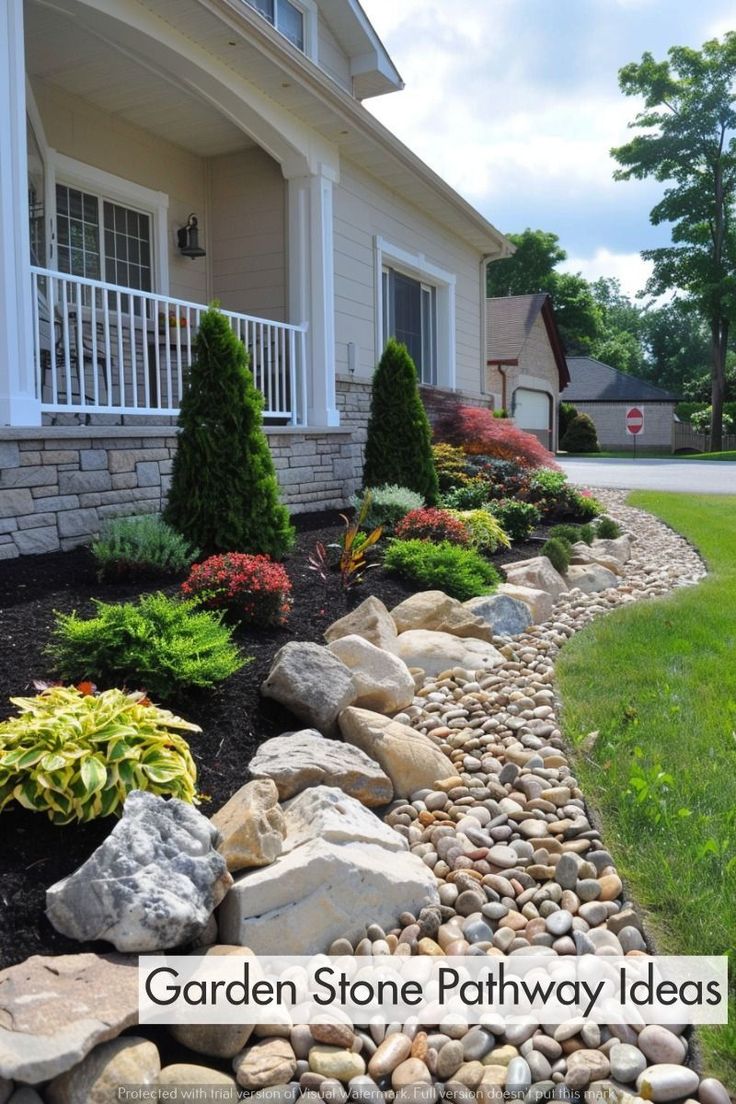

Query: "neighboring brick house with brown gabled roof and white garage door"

xmin=486 ymin=291 xmax=569 ymax=452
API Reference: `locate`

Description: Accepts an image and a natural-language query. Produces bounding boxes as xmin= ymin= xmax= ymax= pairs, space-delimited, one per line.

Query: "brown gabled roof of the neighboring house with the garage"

xmin=486 ymin=291 xmax=569 ymax=391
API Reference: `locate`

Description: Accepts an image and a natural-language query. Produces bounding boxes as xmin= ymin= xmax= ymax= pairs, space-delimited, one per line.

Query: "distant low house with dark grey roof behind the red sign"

xmin=563 ymin=357 xmax=678 ymax=448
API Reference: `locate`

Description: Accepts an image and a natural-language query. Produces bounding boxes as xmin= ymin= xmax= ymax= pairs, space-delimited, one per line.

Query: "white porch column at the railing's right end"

xmin=288 ymin=166 xmax=340 ymax=426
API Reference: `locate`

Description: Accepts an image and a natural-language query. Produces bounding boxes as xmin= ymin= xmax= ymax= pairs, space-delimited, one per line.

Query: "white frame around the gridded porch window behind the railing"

xmin=47 ymin=149 xmax=169 ymax=296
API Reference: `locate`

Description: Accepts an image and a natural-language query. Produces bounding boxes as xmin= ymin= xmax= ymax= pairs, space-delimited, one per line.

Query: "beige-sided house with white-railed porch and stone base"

xmin=0 ymin=0 xmax=511 ymax=558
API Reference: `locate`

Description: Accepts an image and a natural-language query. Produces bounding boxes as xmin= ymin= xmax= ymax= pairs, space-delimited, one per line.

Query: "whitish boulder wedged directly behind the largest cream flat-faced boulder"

xmin=284 ymin=786 xmax=408 ymax=851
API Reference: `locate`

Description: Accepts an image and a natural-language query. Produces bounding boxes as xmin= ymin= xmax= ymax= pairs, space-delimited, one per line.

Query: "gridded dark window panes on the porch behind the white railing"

xmin=56 ymin=183 xmax=152 ymax=291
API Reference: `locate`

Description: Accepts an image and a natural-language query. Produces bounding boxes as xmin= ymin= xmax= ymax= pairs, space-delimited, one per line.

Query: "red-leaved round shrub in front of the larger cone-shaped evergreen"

xmin=181 ymin=552 xmax=291 ymax=625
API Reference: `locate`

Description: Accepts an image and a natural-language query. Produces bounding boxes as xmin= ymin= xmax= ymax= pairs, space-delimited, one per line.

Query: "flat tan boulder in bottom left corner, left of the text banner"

xmin=0 ymin=954 xmax=138 ymax=1084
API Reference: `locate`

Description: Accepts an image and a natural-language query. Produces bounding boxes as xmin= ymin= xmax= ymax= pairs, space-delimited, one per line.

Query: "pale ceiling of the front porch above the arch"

xmin=25 ymin=0 xmax=255 ymax=157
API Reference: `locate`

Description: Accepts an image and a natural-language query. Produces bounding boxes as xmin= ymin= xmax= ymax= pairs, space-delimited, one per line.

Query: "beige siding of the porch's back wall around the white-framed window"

xmin=33 ymin=81 xmax=207 ymax=302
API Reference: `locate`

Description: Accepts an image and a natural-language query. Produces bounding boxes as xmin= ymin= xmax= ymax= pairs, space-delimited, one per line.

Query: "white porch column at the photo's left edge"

xmin=0 ymin=0 xmax=41 ymax=425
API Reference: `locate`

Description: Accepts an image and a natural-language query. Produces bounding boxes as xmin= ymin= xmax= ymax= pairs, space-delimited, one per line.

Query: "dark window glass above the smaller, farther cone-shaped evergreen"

xmin=382 ymin=268 xmax=437 ymax=384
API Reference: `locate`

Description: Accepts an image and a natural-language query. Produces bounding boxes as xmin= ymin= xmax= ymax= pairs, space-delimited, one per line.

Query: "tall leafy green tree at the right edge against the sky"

xmin=611 ymin=32 xmax=736 ymax=452
